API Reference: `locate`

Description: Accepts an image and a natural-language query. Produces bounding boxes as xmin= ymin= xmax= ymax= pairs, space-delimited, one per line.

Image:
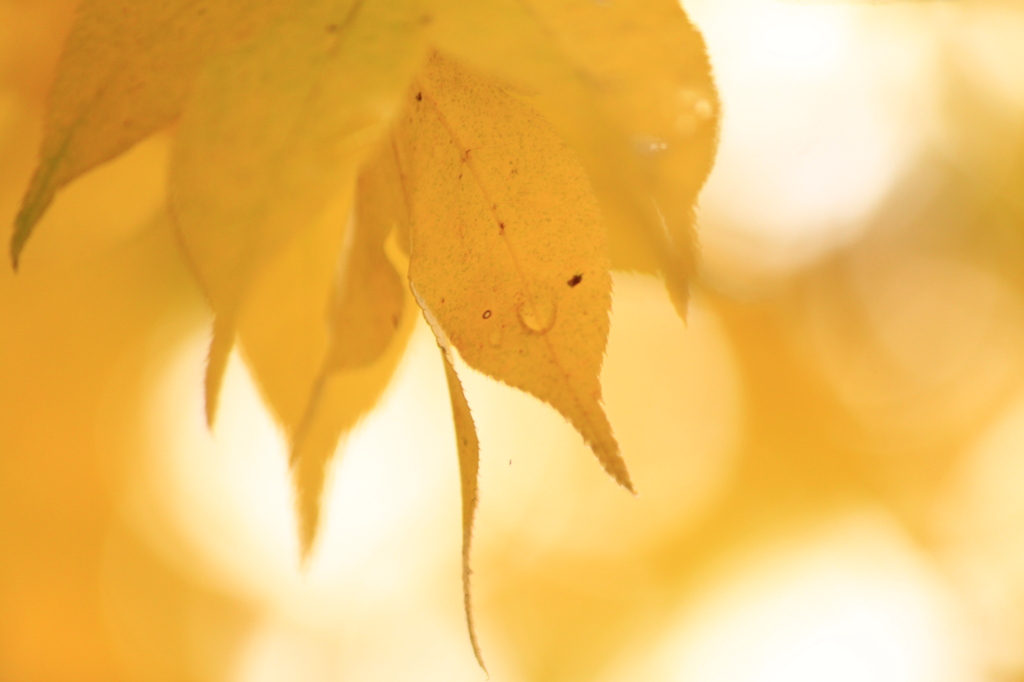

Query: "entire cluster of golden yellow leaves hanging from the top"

xmin=4 ymin=0 xmax=718 ymax=657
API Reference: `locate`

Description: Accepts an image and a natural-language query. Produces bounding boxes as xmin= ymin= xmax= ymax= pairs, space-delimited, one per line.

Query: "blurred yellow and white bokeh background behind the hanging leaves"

xmin=0 ymin=0 xmax=1024 ymax=682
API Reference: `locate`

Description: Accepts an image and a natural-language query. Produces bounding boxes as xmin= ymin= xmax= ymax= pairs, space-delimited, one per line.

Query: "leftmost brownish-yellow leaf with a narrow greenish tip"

xmin=10 ymin=0 xmax=294 ymax=266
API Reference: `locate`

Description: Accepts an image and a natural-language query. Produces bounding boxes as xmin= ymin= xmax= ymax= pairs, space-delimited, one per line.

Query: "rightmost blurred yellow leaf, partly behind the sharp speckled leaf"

xmin=419 ymin=0 xmax=719 ymax=313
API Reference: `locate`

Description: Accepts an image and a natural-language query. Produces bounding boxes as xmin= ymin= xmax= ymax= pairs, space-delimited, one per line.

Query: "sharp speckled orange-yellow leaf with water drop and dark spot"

xmin=397 ymin=55 xmax=632 ymax=489
